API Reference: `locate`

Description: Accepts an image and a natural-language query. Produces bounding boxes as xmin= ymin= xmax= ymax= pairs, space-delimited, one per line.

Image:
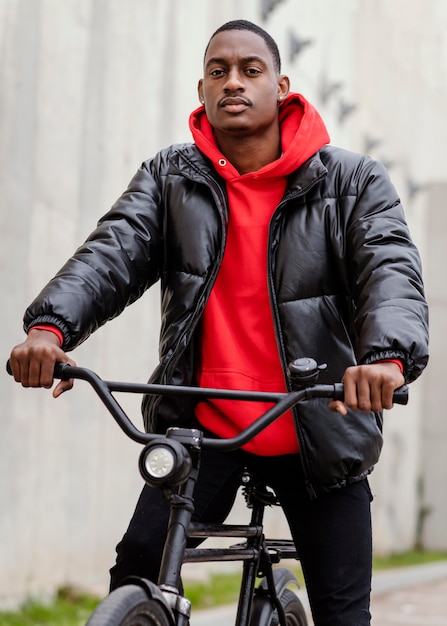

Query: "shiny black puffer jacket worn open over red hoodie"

xmin=25 ymin=144 xmax=427 ymax=491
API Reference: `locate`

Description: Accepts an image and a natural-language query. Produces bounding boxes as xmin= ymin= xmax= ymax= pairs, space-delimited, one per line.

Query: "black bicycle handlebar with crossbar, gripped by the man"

xmin=6 ymin=361 xmax=408 ymax=451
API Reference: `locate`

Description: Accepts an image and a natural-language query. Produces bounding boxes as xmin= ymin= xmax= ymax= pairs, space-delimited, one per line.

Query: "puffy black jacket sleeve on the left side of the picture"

xmin=24 ymin=160 xmax=166 ymax=350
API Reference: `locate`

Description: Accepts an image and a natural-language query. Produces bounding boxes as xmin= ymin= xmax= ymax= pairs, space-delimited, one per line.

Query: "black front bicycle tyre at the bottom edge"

xmin=86 ymin=585 xmax=172 ymax=626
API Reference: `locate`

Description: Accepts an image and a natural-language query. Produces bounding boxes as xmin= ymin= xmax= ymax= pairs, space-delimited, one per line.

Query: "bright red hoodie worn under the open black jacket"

xmin=190 ymin=94 xmax=329 ymax=456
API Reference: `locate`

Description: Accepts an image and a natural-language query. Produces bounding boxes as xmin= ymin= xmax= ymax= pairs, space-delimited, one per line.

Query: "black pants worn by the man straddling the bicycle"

xmin=111 ymin=451 xmax=372 ymax=626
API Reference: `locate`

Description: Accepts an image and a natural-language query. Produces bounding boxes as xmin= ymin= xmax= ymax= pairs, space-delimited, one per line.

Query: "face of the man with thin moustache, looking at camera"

xmin=199 ymin=30 xmax=288 ymax=136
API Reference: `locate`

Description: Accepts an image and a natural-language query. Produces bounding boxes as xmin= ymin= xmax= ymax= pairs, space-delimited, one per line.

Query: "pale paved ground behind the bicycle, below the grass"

xmin=191 ymin=561 xmax=447 ymax=626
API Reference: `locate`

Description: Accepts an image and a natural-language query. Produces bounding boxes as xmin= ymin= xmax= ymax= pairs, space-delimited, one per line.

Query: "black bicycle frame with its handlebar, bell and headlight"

xmin=7 ymin=359 xmax=408 ymax=626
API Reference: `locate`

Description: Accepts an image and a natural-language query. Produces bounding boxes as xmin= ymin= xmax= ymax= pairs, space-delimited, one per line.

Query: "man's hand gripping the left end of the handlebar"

xmin=9 ymin=330 xmax=76 ymax=398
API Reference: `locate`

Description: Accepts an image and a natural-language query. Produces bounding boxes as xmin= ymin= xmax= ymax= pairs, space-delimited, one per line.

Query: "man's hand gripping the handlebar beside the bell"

xmin=329 ymin=361 xmax=405 ymax=415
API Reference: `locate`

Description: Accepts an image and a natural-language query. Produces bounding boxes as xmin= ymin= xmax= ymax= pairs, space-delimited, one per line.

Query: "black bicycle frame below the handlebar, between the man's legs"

xmin=144 ymin=429 xmax=299 ymax=626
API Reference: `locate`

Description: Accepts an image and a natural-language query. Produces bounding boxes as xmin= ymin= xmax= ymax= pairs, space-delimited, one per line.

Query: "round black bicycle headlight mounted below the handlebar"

xmin=139 ymin=439 xmax=192 ymax=487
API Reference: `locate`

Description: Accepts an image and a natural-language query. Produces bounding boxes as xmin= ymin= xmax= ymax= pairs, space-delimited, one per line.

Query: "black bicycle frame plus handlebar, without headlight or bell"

xmin=56 ymin=365 xmax=318 ymax=626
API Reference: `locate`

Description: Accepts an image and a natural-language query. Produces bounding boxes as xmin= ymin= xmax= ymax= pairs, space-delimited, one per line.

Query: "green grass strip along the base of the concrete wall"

xmin=0 ymin=550 xmax=447 ymax=626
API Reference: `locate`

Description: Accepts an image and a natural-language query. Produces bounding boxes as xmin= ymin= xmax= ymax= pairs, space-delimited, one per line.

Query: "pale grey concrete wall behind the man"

xmin=0 ymin=0 xmax=447 ymax=606
